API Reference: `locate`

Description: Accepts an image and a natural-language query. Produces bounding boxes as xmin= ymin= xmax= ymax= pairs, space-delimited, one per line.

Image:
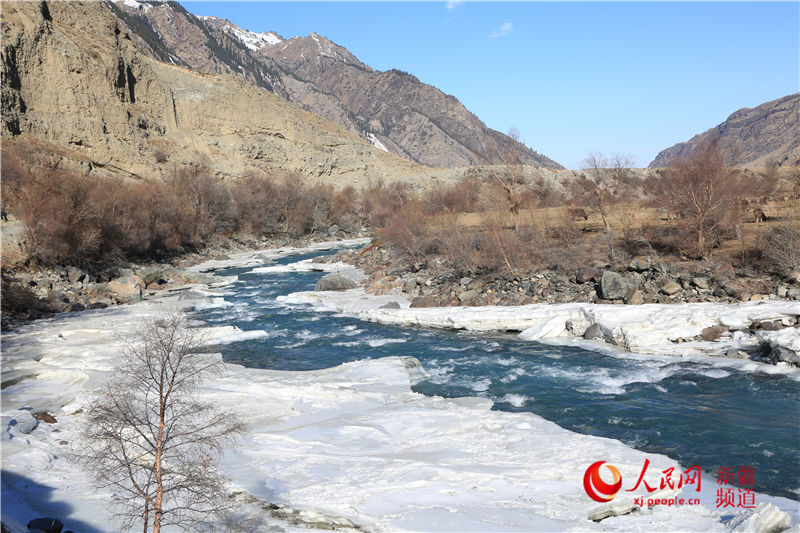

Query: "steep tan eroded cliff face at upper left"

xmin=2 ymin=2 xmax=424 ymax=180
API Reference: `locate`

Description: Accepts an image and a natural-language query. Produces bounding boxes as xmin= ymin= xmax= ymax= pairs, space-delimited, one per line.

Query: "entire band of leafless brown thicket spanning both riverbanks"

xmin=2 ymin=142 xmax=800 ymax=282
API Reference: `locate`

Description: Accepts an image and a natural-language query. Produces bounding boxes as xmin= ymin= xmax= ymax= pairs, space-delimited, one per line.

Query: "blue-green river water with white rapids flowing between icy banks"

xmin=199 ymin=247 xmax=800 ymax=500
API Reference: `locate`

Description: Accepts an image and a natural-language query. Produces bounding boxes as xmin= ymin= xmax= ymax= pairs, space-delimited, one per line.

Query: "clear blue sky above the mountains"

xmin=181 ymin=2 xmax=800 ymax=168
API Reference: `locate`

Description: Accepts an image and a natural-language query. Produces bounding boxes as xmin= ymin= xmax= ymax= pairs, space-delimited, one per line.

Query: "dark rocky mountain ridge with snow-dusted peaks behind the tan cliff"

xmin=108 ymin=0 xmax=562 ymax=168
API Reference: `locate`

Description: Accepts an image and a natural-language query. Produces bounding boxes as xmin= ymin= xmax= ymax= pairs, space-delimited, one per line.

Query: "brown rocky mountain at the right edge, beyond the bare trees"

xmin=650 ymin=93 xmax=800 ymax=168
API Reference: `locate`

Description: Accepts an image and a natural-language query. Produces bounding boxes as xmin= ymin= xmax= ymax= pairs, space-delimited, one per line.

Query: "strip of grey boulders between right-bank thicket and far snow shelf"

xmin=324 ymin=245 xmax=800 ymax=307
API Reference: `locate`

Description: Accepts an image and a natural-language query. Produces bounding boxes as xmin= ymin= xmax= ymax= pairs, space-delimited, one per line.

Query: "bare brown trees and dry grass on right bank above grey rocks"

xmin=377 ymin=143 xmax=797 ymax=278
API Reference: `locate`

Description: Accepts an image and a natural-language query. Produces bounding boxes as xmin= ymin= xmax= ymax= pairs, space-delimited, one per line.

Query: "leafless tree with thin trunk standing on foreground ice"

xmin=75 ymin=314 xmax=245 ymax=533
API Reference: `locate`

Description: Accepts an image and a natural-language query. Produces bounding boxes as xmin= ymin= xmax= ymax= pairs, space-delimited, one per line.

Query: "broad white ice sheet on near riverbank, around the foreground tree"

xmin=2 ymin=243 xmax=797 ymax=531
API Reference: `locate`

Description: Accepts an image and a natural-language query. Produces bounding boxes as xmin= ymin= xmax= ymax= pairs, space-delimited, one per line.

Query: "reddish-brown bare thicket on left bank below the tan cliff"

xmin=2 ymin=145 xmax=364 ymax=265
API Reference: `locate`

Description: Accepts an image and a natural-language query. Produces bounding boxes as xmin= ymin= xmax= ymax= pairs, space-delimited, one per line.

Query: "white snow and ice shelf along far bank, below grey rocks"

xmin=279 ymin=289 xmax=800 ymax=364
